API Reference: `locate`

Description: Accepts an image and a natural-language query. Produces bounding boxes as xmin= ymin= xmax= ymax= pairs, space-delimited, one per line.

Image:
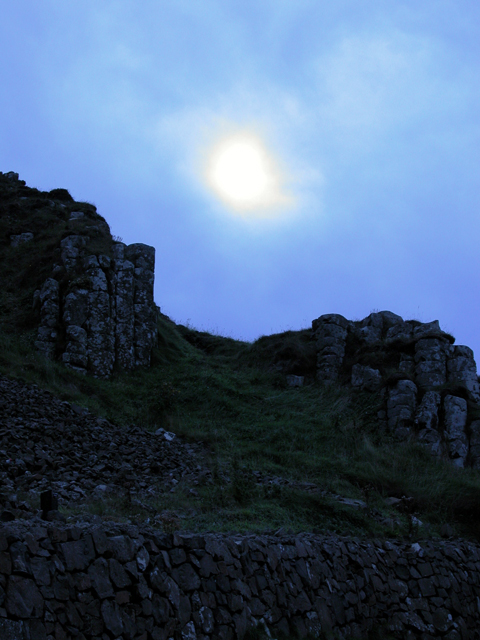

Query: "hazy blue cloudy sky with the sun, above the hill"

xmin=0 ymin=0 xmax=480 ymax=359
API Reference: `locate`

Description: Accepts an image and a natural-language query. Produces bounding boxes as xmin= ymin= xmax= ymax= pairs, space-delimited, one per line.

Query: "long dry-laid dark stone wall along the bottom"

xmin=0 ymin=523 xmax=480 ymax=640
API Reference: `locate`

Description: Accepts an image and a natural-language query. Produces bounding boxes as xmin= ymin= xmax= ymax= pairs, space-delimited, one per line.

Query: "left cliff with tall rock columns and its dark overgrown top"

xmin=0 ymin=172 xmax=157 ymax=378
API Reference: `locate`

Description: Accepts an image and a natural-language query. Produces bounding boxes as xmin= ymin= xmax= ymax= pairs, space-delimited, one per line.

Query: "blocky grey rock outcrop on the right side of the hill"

xmin=312 ymin=311 xmax=480 ymax=469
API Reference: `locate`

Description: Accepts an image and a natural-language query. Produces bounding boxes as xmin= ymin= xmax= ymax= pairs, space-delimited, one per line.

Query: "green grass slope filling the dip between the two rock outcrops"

xmin=0 ymin=316 xmax=480 ymax=537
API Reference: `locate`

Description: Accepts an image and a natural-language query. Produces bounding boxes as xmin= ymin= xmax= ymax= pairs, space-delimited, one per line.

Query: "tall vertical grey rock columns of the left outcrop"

xmin=35 ymin=234 xmax=156 ymax=378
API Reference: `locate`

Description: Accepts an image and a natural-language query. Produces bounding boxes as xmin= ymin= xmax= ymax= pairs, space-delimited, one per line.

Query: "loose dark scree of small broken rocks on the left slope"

xmin=0 ymin=377 xmax=210 ymax=512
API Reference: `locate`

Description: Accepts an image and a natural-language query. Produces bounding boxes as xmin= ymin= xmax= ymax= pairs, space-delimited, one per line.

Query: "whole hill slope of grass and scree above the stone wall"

xmin=0 ymin=171 xmax=480 ymax=537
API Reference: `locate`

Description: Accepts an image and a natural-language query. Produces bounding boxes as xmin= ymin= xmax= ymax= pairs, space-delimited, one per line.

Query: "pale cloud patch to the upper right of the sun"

xmin=314 ymin=31 xmax=464 ymax=152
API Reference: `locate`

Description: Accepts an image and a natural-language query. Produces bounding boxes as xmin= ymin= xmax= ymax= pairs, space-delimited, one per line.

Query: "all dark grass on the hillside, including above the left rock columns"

xmin=0 ymin=178 xmax=480 ymax=539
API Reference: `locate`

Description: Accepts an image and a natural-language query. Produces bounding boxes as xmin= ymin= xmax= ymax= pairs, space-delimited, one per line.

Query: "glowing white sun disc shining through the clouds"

xmin=206 ymin=132 xmax=288 ymax=215
